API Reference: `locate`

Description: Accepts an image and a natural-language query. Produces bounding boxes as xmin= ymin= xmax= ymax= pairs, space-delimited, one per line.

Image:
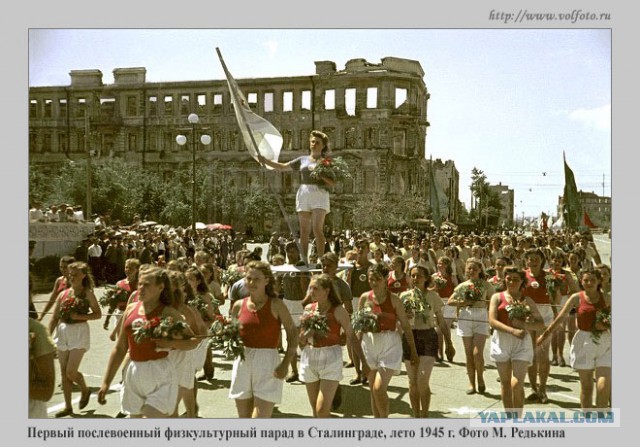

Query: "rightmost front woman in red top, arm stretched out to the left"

xmin=537 ymin=267 xmax=611 ymax=410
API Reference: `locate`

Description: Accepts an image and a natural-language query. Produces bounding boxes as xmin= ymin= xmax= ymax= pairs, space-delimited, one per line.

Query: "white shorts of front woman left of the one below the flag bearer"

xmin=229 ymin=347 xmax=284 ymax=404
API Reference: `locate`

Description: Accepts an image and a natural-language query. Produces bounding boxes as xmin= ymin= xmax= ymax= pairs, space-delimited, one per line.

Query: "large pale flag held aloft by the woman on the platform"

xmin=216 ymin=48 xmax=284 ymax=169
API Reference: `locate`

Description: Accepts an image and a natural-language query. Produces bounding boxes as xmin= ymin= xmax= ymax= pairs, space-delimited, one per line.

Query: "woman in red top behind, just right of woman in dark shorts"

xmin=431 ymin=256 xmax=458 ymax=363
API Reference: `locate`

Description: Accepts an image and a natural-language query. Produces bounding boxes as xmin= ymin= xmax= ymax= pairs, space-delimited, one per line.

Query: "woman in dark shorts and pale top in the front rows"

xmin=400 ymin=265 xmax=453 ymax=418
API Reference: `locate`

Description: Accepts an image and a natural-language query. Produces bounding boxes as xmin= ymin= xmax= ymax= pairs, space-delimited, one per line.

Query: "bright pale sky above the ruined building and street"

xmin=28 ymin=28 xmax=612 ymax=217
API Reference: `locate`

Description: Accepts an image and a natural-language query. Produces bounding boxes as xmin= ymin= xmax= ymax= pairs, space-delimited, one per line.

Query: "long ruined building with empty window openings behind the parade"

xmin=29 ymin=57 xmax=458 ymax=230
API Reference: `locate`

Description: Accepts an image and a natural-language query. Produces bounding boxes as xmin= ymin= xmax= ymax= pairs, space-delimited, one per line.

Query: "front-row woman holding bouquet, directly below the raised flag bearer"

xmin=300 ymin=274 xmax=369 ymax=418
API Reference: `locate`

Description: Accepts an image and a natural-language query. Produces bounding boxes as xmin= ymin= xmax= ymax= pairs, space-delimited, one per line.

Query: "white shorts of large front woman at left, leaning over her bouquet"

xmin=120 ymin=357 xmax=178 ymax=415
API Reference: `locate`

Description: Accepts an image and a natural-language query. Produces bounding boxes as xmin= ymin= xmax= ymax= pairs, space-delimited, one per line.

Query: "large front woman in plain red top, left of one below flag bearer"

xmin=229 ymin=261 xmax=298 ymax=418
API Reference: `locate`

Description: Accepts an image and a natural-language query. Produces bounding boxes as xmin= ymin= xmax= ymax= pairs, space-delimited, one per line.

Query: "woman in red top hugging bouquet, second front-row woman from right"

xmin=489 ymin=266 xmax=544 ymax=416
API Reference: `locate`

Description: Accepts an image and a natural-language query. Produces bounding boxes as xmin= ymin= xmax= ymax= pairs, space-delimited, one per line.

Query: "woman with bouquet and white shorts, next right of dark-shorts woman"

xmin=447 ymin=257 xmax=493 ymax=394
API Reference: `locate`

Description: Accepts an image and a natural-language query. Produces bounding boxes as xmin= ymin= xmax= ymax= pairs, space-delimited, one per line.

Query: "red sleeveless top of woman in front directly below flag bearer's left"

xmin=238 ymin=298 xmax=280 ymax=349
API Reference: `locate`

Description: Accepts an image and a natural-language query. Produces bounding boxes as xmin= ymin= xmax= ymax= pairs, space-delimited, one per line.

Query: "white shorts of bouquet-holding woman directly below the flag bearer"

xmin=298 ymin=345 xmax=342 ymax=383
